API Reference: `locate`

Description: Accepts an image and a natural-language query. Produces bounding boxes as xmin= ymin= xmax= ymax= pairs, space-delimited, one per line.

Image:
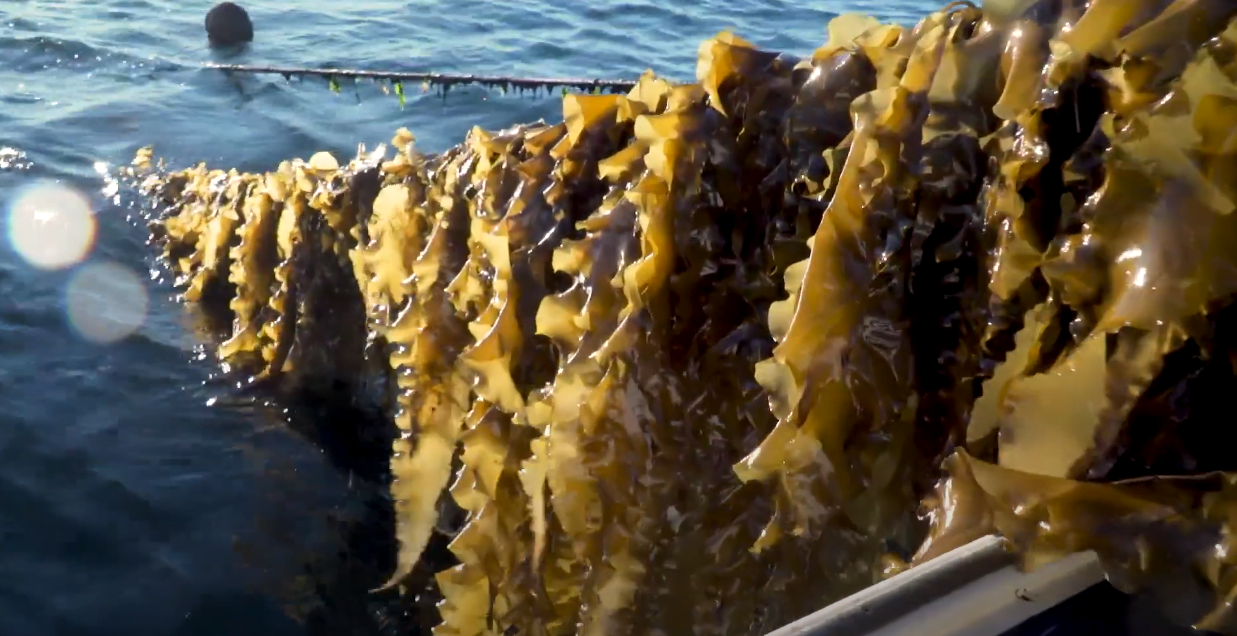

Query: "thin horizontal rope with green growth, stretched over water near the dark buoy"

xmin=203 ymin=64 xmax=636 ymax=93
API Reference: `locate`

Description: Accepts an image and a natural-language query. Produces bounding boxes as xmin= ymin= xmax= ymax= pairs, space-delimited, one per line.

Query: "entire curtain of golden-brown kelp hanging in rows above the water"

xmin=139 ymin=0 xmax=1237 ymax=635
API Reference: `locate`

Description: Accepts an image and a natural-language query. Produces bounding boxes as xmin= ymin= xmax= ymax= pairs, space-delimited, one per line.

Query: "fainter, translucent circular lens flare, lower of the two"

xmin=66 ymin=262 xmax=150 ymax=344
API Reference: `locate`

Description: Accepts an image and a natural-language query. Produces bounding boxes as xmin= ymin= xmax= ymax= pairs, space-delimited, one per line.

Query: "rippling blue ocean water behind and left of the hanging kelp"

xmin=0 ymin=0 xmax=936 ymax=636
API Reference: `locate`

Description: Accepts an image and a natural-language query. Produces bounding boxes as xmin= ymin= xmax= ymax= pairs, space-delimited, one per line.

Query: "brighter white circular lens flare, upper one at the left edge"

xmin=6 ymin=182 xmax=95 ymax=270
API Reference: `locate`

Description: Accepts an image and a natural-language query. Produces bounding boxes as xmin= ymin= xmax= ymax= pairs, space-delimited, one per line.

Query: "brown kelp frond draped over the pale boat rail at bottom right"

xmin=917 ymin=450 xmax=1237 ymax=634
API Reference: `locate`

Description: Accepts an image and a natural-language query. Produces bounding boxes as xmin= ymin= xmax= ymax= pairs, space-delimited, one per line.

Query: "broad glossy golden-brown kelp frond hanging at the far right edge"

xmin=979 ymin=9 xmax=1237 ymax=479
